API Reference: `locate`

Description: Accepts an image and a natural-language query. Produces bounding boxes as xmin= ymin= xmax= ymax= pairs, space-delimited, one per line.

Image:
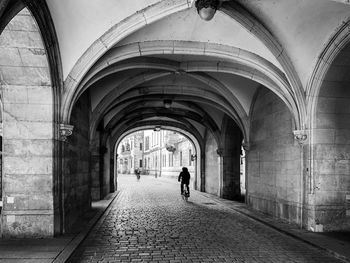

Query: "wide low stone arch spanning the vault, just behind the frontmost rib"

xmin=63 ymin=41 xmax=300 ymax=127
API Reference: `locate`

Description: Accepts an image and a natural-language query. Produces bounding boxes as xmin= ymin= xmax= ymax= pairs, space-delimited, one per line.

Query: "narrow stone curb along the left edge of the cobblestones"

xmin=52 ymin=191 xmax=120 ymax=263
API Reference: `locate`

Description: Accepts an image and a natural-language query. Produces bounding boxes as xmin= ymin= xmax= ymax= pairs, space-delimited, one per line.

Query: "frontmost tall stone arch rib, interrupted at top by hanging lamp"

xmin=61 ymin=1 xmax=306 ymax=128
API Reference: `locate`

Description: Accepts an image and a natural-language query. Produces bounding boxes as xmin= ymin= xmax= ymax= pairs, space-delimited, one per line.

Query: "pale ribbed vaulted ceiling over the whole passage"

xmin=42 ymin=0 xmax=350 ymax=144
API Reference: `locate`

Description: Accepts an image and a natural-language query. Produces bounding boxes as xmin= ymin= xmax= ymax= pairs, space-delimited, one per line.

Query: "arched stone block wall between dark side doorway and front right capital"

xmin=247 ymin=88 xmax=302 ymax=225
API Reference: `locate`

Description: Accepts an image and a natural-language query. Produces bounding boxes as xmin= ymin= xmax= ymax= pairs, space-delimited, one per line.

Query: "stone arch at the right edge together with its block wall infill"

xmin=306 ymin=20 xmax=350 ymax=231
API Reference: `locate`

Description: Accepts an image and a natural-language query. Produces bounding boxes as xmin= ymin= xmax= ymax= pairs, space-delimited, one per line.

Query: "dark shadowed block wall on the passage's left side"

xmin=64 ymin=93 xmax=91 ymax=232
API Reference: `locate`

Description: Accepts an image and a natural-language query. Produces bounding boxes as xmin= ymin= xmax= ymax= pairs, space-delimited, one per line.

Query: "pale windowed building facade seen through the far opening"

xmin=117 ymin=129 xmax=196 ymax=178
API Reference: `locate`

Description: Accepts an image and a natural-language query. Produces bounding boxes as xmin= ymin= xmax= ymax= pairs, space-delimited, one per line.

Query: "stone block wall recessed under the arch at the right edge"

xmin=311 ymin=46 xmax=350 ymax=231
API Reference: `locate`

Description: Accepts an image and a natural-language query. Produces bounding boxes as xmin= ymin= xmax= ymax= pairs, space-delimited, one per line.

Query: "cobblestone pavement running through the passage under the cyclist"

xmin=69 ymin=175 xmax=341 ymax=263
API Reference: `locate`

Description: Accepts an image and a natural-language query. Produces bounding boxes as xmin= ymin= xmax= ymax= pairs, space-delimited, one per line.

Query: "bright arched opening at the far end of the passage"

xmin=114 ymin=125 xmax=202 ymax=193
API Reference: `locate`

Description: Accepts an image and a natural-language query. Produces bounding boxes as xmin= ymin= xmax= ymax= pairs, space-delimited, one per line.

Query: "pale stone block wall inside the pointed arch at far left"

xmin=0 ymin=9 xmax=54 ymax=237
